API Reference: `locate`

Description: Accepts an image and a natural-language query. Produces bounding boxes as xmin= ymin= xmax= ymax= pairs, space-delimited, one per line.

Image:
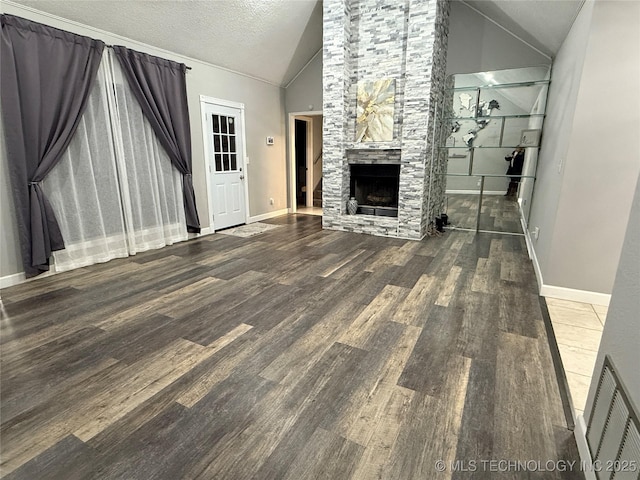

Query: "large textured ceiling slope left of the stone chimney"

xmin=14 ymin=0 xmax=322 ymax=85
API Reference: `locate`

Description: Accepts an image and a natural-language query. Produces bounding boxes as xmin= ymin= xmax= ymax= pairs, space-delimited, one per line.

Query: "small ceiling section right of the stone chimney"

xmin=463 ymin=0 xmax=584 ymax=57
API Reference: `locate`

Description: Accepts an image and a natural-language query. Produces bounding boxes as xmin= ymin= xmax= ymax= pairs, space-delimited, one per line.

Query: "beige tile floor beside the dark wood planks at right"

xmin=545 ymin=298 xmax=607 ymax=416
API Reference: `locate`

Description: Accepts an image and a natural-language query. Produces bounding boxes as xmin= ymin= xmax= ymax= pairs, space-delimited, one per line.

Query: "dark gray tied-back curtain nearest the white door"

xmin=113 ymin=46 xmax=200 ymax=233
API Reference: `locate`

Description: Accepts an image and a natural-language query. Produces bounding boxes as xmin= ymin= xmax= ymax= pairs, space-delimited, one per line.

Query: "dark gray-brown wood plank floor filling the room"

xmin=0 ymin=215 xmax=582 ymax=480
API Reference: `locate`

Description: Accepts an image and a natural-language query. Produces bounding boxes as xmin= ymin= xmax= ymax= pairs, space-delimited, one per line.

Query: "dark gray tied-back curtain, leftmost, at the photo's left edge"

xmin=0 ymin=15 xmax=104 ymax=277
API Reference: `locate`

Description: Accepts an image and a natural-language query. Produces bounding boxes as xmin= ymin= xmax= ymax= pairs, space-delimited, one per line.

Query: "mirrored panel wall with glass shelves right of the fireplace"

xmin=442 ymin=66 xmax=550 ymax=234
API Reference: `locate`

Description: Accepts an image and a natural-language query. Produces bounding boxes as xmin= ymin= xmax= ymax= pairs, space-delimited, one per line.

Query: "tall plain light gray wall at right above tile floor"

xmin=529 ymin=0 xmax=640 ymax=303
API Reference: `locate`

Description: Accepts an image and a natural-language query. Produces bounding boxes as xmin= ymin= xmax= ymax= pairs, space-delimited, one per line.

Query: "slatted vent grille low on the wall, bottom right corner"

xmin=586 ymin=355 xmax=640 ymax=480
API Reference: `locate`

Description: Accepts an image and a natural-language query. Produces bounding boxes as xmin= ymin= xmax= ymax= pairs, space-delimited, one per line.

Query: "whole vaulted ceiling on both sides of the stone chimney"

xmin=6 ymin=0 xmax=584 ymax=86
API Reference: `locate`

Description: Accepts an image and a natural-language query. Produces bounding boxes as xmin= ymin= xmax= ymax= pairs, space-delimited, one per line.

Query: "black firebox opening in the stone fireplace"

xmin=350 ymin=164 xmax=400 ymax=217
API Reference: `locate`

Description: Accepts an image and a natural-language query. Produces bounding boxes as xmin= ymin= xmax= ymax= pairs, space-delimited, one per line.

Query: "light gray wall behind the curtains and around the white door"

xmin=0 ymin=3 xmax=287 ymax=277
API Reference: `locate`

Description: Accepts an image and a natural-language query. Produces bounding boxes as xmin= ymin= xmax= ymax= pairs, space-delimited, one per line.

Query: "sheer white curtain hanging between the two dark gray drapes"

xmin=43 ymin=51 xmax=187 ymax=271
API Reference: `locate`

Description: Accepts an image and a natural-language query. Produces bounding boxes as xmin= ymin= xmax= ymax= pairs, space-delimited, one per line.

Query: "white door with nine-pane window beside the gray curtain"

xmin=204 ymin=103 xmax=246 ymax=230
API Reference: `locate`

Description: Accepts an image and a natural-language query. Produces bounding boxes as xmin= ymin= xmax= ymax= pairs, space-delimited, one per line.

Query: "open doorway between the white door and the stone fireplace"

xmin=289 ymin=112 xmax=322 ymax=215
